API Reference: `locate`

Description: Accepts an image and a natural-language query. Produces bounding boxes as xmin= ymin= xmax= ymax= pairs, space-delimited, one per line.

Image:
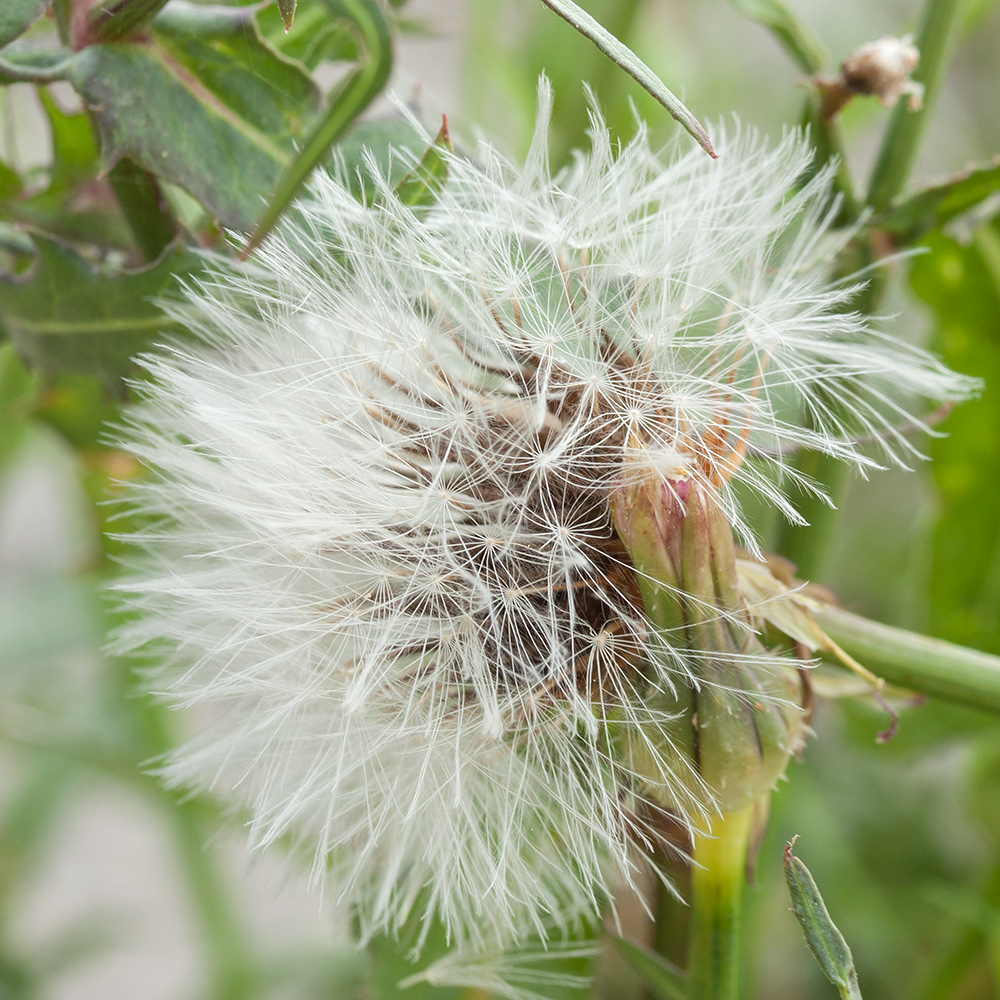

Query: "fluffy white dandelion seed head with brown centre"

xmin=111 ymin=86 xmax=972 ymax=947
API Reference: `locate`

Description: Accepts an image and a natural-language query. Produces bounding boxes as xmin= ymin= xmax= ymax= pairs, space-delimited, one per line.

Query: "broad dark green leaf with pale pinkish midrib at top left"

xmin=66 ymin=0 xmax=317 ymax=228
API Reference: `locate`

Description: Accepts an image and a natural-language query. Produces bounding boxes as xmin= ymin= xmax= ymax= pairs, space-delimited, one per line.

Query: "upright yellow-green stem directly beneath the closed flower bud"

xmin=688 ymin=805 xmax=753 ymax=1000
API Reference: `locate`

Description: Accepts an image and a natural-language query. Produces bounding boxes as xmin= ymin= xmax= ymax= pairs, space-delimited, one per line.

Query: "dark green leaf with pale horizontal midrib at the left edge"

xmin=0 ymin=236 xmax=201 ymax=386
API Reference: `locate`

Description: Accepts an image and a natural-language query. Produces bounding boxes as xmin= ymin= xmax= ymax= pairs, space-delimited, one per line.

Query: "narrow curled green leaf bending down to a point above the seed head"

xmin=241 ymin=0 xmax=392 ymax=257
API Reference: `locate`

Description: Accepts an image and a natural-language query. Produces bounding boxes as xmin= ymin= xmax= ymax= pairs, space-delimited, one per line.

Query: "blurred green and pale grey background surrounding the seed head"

xmin=0 ymin=0 xmax=1000 ymax=1000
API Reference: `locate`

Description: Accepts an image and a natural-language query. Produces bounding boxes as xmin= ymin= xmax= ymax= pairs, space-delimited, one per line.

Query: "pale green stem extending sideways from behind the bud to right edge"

xmin=813 ymin=605 xmax=1000 ymax=712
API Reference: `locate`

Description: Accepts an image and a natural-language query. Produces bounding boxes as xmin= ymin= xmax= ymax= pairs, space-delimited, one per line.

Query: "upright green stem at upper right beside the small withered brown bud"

xmin=868 ymin=0 xmax=962 ymax=210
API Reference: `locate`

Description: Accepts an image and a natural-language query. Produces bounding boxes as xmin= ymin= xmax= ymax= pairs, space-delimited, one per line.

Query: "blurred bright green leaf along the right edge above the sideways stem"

xmin=910 ymin=221 xmax=1000 ymax=653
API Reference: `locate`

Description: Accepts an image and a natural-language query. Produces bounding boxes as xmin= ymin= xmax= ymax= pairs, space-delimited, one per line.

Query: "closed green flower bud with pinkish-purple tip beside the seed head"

xmin=612 ymin=477 xmax=805 ymax=813
